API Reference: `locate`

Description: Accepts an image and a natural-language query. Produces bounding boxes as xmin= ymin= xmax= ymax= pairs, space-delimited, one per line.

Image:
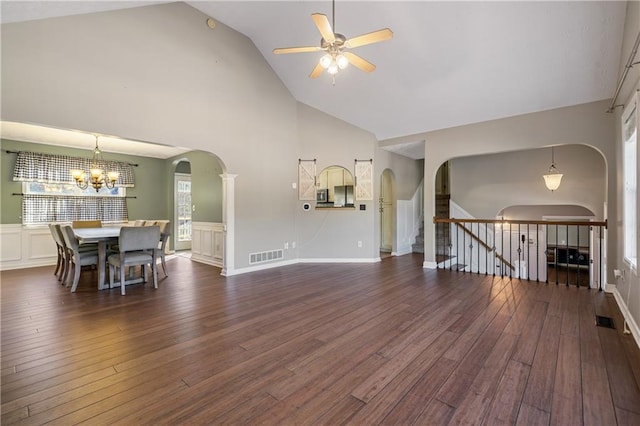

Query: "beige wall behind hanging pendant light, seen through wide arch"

xmin=450 ymin=145 xmax=606 ymax=220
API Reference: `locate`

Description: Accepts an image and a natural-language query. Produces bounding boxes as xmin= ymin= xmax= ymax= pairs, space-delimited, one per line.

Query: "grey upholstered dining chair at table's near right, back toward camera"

xmin=107 ymin=226 xmax=160 ymax=296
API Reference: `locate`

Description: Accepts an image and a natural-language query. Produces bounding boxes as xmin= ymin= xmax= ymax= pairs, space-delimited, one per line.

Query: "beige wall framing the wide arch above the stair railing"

xmin=383 ymin=101 xmax=616 ymax=266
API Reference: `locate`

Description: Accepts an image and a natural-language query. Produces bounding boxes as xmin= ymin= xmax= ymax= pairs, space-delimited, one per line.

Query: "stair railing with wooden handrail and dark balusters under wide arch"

xmin=433 ymin=217 xmax=607 ymax=290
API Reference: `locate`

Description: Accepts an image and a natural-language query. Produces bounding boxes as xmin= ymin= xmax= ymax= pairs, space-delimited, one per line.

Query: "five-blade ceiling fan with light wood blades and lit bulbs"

xmin=273 ymin=0 xmax=393 ymax=79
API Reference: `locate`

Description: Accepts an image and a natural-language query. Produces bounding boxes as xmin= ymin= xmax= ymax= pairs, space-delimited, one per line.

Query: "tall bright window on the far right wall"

xmin=622 ymin=92 xmax=638 ymax=268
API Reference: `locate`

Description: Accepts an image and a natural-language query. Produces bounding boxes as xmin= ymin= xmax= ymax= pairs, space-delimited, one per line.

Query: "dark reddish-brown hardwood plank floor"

xmin=0 ymin=255 xmax=640 ymax=425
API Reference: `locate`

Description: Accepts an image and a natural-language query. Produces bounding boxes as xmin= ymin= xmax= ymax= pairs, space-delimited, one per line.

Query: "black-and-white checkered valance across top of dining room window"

xmin=13 ymin=151 xmax=135 ymax=187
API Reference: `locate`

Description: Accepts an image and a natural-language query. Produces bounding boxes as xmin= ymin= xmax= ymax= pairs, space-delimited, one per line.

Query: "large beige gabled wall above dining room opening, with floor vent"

xmin=1 ymin=3 xmax=424 ymax=270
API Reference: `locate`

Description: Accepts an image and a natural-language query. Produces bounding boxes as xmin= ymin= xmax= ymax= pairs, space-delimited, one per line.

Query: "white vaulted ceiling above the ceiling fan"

xmin=2 ymin=0 xmax=626 ymax=158
